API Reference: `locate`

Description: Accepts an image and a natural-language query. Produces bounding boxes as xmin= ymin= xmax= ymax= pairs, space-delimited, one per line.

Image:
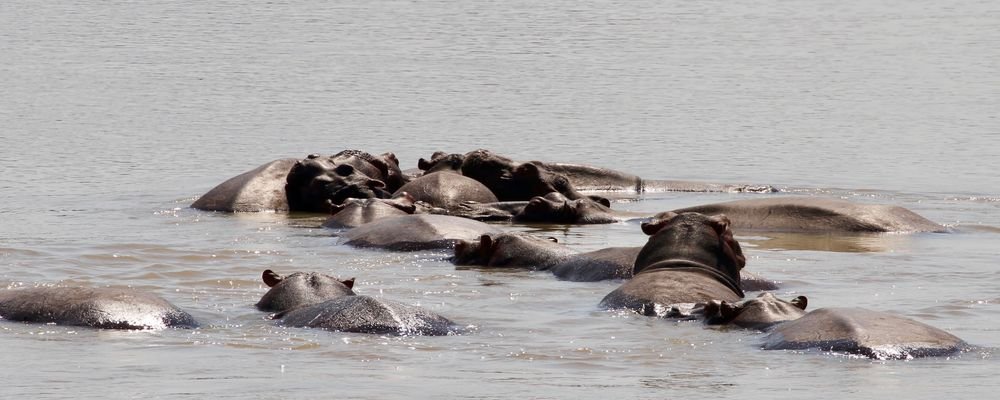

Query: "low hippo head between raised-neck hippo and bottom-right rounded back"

xmin=703 ymin=292 xmax=808 ymax=330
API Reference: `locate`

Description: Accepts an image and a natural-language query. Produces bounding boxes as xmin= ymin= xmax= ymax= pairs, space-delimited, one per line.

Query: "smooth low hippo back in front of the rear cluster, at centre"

xmin=340 ymin=214 xmax=501 ymax=251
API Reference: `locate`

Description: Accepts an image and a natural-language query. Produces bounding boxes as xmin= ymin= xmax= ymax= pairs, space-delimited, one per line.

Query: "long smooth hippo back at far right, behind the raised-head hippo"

xmin=673 ymin=197 xmax=947 ymax=233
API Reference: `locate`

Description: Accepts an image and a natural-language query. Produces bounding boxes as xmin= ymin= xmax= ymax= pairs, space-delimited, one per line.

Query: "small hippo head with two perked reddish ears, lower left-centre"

xmin=257 ymin=270 xmax=354 ymax=312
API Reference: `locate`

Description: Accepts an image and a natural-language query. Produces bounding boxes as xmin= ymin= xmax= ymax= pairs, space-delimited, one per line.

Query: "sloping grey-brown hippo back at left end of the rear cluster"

xmin=191 ymin=158 xmax=299 ymax=212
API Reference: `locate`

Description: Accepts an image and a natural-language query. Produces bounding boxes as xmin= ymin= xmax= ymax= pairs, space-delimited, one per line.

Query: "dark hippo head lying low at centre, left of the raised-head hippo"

xmin=452 ymin=233 xmax=566 ymax=267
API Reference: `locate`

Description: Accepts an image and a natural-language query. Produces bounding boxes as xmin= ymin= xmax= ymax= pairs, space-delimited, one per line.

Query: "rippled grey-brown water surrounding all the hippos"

xmin=0 ymin=0 xmax=1000 ymax=399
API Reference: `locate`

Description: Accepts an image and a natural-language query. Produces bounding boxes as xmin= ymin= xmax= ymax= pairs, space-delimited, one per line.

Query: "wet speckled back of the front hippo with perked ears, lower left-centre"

xmin=280 ymin=295 xmax=457 ymax=336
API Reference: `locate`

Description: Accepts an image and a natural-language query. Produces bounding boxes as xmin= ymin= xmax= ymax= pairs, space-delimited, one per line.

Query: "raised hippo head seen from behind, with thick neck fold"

xmin=634 ymin=212 xmax=746 ymax=283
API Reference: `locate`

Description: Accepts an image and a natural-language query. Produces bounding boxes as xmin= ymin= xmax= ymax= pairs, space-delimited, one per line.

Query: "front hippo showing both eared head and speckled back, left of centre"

xmin=257 ymin=270 xmax=459 ymax=336
